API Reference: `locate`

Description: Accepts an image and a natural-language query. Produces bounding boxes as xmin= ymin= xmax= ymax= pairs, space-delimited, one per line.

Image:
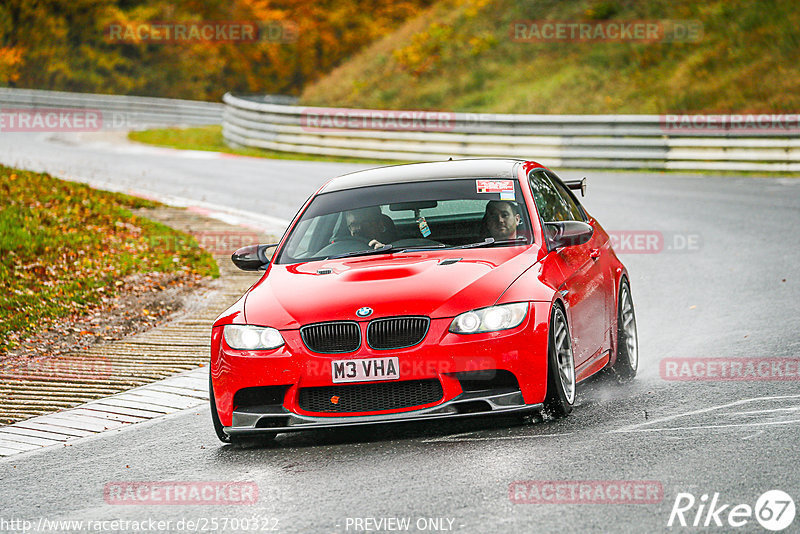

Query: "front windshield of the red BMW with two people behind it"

xmin=276 ymin=178 xmax=532 ymax=264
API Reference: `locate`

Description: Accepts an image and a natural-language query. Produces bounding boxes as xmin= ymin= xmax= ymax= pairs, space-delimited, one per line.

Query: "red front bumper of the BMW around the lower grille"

xmin=211 ymin=302 xmax=550 ymax=435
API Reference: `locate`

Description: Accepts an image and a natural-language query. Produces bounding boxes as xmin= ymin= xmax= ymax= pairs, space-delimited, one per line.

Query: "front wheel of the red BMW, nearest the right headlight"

xmin=544 ymin=305 xmax=576 ymax=417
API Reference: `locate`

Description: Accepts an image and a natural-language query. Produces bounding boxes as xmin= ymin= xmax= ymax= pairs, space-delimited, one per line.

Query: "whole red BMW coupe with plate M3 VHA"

xmin=210 ymin=159 xmax=638 ymax=442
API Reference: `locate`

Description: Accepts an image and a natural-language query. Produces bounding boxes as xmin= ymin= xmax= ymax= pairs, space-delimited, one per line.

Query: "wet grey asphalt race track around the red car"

xmin=0 ymin=134 xmax=800 ymax=532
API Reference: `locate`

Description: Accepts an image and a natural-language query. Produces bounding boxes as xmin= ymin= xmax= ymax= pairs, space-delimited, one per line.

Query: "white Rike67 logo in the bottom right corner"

xmin=667 ymin=490 xmax=795 ymax=532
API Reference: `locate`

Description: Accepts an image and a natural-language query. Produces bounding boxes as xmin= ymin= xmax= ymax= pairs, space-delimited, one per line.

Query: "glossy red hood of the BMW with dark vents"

xmin=245 ymin=246 xmax=538 ymax=329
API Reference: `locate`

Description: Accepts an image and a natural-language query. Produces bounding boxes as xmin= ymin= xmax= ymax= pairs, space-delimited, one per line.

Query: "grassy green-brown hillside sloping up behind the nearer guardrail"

xmin=302 ymin=0 xmax=800 ymax=114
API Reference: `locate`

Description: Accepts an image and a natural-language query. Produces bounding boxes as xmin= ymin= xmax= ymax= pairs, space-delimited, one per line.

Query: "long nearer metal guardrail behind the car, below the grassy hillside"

xmin=223 ymin=93 xmax=800 ymax=172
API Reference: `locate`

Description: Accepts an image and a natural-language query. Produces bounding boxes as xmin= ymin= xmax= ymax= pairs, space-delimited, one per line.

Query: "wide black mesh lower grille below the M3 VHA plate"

xmin=299 ymin=379 xmax=444 ymax=413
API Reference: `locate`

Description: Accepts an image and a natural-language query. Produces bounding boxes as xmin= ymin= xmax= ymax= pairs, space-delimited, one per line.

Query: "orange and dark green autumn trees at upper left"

xmin=0 ymin=0 xmax=431 ymax=100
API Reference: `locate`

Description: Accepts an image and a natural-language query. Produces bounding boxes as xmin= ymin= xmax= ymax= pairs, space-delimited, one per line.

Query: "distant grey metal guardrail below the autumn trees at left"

xmin=0 ymin=87 xmax=225 ymax=130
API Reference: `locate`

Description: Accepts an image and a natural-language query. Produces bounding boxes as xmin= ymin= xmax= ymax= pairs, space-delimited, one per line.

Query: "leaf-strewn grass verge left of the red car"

xmin=0 ymin=165 xmax=219 ymax=353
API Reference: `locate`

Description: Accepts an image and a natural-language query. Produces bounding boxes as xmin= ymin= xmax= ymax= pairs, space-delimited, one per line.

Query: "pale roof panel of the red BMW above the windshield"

xmin=319 ymin=158 xmax=536 ymax=193
